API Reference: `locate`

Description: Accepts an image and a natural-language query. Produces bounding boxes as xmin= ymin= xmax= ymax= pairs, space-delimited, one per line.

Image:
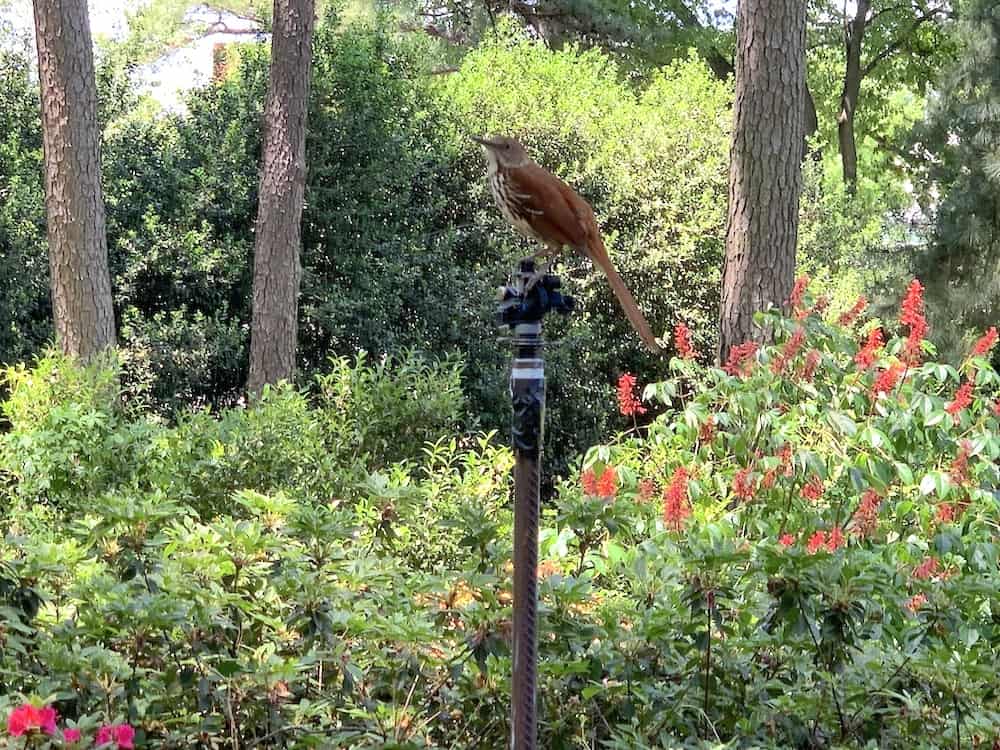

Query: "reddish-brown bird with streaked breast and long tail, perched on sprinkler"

xmin=472 ymin=137 xmax=663 ymax=353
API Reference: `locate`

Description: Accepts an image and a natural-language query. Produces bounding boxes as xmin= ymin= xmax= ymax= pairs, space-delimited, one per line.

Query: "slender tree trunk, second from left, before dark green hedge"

xmin=247 ymin=0 xmax=315 ymax=395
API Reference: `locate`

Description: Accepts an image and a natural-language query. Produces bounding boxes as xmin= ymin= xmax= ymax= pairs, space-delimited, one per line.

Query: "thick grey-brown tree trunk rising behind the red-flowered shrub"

xmin=719 ymin=0 xmax=806 ymax=362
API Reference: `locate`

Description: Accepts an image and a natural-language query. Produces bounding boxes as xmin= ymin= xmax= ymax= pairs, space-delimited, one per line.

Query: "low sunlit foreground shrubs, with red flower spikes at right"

xmin=0 ymin=284 xmax=1000 ymax=749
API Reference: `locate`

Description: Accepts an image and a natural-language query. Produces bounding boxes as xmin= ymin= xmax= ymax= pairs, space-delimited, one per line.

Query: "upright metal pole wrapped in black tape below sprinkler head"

xmin=510 ymin=321 xmax=545 ymax=750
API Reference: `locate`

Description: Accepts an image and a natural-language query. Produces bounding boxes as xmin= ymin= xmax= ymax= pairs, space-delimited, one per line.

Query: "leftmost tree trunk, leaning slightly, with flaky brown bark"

xmin=34 ymin=0 xmax=115 ymax=361
